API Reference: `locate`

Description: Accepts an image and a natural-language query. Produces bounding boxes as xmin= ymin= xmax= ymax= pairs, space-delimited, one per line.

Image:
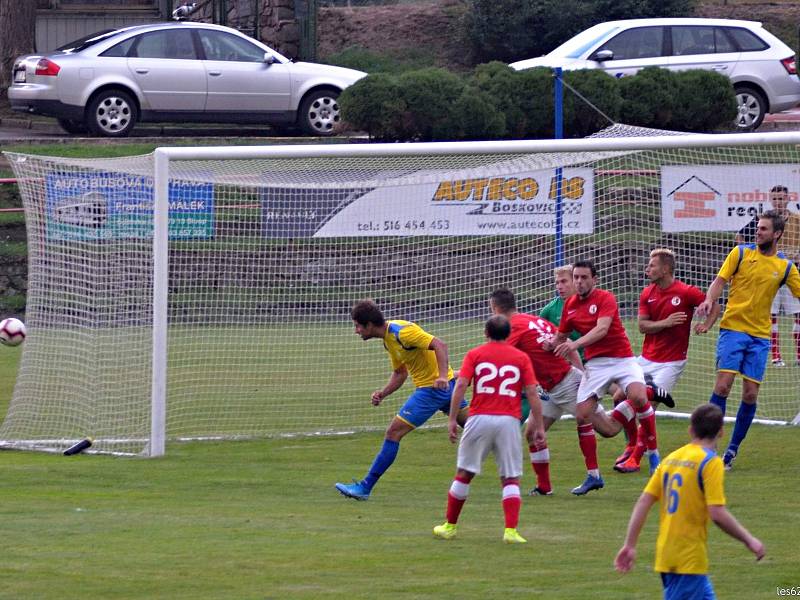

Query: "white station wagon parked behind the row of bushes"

xmin=511 ymin=18 xmax=800 ymax=130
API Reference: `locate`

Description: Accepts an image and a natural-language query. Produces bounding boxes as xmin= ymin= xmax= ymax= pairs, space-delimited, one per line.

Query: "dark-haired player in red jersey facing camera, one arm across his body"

xmin=554 ymin=260 xmax=659 ymax=495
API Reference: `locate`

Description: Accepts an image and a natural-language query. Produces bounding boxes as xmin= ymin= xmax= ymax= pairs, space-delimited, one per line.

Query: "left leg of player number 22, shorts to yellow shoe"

xmin=433 ymin=415 xmax=490 ymax=539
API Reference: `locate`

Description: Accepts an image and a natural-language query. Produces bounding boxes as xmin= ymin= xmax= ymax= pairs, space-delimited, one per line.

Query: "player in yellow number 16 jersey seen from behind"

xmin=614 ymin=404 xmax=765 ymax=600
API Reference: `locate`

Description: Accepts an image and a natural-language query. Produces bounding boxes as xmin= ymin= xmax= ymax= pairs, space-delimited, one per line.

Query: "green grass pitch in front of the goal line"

xmin=0 ymin=348 xmax=800 ymax=600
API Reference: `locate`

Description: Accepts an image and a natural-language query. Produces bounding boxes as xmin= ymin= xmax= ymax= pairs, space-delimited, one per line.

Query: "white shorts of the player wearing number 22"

xmin=456 ymin=415 xmax=522 ymax=478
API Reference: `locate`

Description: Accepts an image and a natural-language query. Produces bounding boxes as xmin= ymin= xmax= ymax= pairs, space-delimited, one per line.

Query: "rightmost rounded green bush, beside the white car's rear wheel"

xmin=670 ymin=69 xmax=736 ymax=132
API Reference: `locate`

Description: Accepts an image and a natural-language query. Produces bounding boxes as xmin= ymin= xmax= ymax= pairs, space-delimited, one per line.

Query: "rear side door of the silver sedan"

xmin=128 ymin=29 xmax=206 ymax=111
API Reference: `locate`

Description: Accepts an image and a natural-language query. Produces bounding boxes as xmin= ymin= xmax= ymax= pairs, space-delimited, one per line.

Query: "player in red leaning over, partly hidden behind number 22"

xmin=489 ymin=288 xmax=619 ymax=496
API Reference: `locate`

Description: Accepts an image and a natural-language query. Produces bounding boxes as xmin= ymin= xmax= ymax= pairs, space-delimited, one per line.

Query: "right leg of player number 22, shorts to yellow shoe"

xmin=492 ymin=415 xmax=526 ymax=544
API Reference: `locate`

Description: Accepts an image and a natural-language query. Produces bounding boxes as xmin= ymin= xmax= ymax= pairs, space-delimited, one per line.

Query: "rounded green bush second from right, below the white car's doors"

xmin=619 ymin=67 xmax=678 ymax=129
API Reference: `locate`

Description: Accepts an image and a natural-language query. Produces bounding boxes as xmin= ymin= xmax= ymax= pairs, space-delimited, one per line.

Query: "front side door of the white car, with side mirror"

xmin=589 ymin=26 xmax=667 ymax=77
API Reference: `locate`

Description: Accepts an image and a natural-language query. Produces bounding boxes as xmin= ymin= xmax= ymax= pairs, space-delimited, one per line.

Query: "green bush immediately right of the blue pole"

xmin=564 ymin=70 xmax=622 ymax=138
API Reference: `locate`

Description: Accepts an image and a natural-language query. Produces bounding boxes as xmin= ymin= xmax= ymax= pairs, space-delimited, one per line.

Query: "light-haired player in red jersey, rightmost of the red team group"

xmin=614 ymin=248 xmax=720 ymax=473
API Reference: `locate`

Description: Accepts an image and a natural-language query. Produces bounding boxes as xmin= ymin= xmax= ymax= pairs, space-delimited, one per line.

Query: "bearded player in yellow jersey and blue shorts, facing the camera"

xmin=697 ymin=210 xmax=800 ymax=469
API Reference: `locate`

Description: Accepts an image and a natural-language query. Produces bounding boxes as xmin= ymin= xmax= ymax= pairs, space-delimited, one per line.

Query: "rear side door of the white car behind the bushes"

xmin=669 ymin=25 xmax=741 ymax=76
